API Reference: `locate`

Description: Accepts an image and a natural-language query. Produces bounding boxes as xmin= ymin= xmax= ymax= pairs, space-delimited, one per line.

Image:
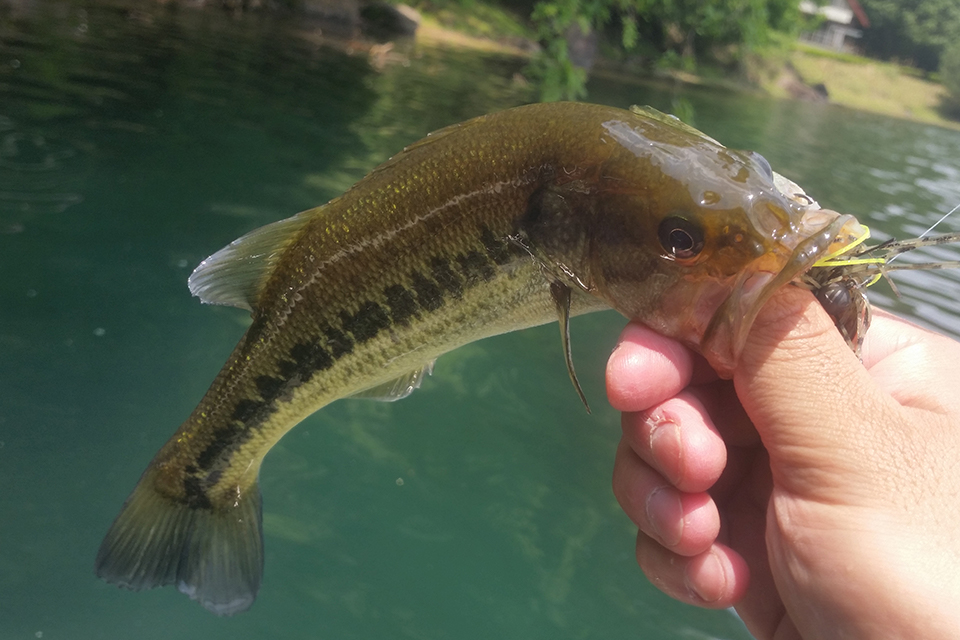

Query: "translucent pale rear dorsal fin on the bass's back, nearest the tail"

xmin=187 ymin=209 xmax=316 ymax=311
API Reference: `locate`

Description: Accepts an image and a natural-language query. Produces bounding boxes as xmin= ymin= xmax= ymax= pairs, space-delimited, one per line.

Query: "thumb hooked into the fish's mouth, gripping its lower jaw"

xmin=733 ymin=287 xmax=897 ymax=500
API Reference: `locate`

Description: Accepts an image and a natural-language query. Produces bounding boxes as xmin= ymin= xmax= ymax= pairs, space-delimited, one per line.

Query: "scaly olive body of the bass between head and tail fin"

xmin=154 ymin=104 xmax=632 ymax=507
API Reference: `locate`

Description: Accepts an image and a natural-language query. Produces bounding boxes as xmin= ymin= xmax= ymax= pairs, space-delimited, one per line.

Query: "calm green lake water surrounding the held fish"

xmin=0 ymin=2 xmax=960 ymax=640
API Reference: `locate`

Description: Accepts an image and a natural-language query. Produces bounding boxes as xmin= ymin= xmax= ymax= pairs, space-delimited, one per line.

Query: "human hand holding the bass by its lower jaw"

xmin=607 ymin=287 xmax=960 ymax=640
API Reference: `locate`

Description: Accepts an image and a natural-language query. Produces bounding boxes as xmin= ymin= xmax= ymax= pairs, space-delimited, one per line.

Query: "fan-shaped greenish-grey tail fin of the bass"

xmin=96 ymin=469 xmax=263 ymax=616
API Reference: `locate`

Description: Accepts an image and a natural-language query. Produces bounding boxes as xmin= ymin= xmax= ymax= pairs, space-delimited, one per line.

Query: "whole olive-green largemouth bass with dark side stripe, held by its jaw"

xmin=96 ymin=103 xmax=860 ymax=615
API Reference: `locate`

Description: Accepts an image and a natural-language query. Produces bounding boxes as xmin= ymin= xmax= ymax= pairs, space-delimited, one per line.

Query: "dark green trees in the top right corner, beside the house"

xmin=861 ymin=0 xmax=960 ymax=71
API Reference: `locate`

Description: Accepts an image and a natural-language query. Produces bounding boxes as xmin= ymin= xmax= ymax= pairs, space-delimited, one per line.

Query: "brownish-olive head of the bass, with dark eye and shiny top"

xmin=591 ymin=116 xmax=864 ymax=377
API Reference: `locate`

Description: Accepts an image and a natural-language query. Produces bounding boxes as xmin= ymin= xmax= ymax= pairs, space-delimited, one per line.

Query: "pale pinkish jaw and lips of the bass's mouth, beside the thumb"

xmin=701 ymin=209 xmax=865 ymax=378
